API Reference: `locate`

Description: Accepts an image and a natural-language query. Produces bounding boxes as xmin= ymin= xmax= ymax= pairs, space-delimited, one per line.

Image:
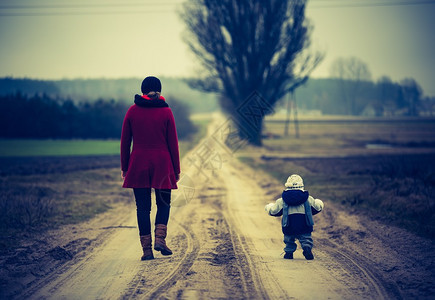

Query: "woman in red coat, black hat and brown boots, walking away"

xmin=121 ymin=76 xmax=180 ymax=260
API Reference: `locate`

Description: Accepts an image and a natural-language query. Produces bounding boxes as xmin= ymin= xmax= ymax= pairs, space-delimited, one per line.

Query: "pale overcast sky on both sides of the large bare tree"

xmin=0 ymin=0 xmax=435 ymax=96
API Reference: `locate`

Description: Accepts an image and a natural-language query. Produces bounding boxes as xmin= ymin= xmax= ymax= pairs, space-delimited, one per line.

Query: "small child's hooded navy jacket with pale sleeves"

xmin=265 ymin=190 xmax=323 ymax=235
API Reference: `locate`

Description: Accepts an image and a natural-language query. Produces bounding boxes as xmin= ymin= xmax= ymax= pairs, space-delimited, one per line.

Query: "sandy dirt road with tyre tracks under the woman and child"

xmin=9 ymin=116 xmax=434 ymax=299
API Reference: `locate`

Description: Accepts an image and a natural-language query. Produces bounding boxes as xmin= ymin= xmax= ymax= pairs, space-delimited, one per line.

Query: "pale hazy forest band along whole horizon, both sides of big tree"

xmin=0 ymin=77 xmax=435 ymax=116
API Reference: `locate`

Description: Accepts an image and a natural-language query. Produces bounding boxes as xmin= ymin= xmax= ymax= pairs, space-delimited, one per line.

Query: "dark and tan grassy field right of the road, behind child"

xmin=239 ymin=120 xmax=435 ymax=239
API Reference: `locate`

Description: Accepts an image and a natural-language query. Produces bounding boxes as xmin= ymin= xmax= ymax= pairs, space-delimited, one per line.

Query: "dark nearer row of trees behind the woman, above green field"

xmin=0 ymin=93 xmax=197 ymax=140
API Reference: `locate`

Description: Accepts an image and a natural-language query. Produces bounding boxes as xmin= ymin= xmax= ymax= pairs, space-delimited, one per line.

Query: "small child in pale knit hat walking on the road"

xmin=264 ymin=174 xmax=323 ymax=260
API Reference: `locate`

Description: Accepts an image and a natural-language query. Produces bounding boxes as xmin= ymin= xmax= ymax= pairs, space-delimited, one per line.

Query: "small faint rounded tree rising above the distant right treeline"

xmin=330 ymin=57 xmax=371 ymax=115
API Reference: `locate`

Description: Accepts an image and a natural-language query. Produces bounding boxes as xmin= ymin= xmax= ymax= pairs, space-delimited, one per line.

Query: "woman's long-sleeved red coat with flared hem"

xmin=121 ymin=95 xmax=180 ymax=189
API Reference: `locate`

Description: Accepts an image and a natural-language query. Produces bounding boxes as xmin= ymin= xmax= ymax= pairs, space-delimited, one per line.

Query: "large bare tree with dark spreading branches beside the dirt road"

xmin=181 ymin=0 xmax=323 ymax=145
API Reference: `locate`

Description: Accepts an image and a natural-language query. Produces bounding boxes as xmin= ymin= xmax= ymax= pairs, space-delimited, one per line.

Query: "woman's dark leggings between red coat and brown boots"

xmin=133 ymin=188 xmax=171 ymax=236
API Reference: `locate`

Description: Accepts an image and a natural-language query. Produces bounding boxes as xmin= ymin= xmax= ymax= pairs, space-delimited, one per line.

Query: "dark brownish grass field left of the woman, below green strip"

xmin=0 ymin=166 xmax=130 ymax=250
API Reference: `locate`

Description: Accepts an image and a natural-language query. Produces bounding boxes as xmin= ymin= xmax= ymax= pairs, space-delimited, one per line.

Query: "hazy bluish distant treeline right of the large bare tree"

xmin=292 ymin=77 xmax=435 ymax=117
